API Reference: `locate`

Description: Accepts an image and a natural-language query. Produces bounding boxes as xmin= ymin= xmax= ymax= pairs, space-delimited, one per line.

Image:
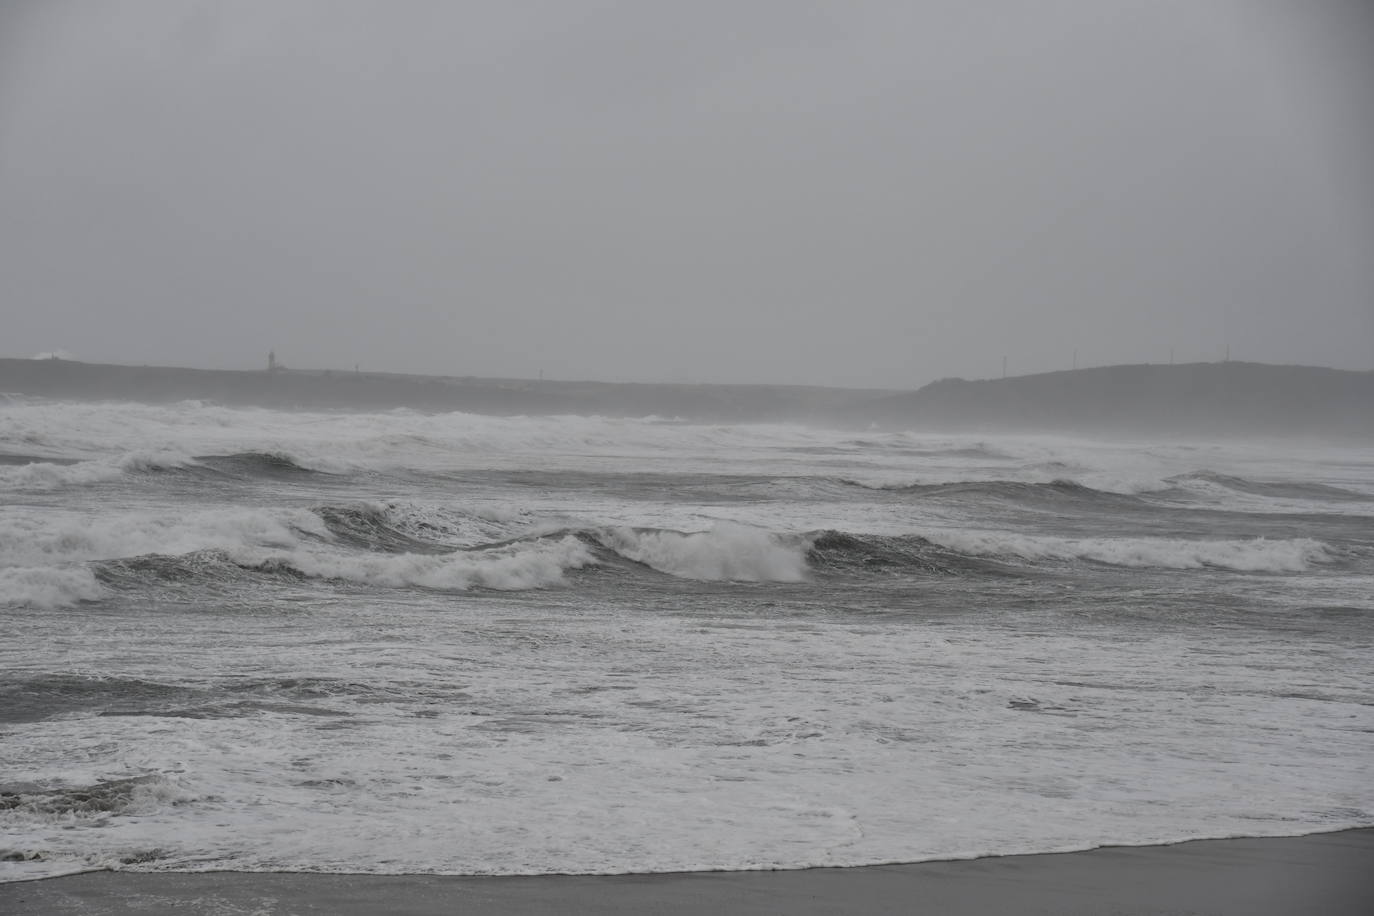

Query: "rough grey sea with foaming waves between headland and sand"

xmin=0 ymin=396 xmax=1374 ymax=880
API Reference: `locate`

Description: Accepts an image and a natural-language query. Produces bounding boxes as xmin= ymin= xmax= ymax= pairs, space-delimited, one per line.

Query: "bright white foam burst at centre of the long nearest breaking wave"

xmin=600 ymin=522 xmax=807 ymax=582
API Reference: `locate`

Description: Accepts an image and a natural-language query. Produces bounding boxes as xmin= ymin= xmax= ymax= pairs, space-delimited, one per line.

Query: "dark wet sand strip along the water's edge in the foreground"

xmin=0 ymin=828 xmax=1374 ymax=916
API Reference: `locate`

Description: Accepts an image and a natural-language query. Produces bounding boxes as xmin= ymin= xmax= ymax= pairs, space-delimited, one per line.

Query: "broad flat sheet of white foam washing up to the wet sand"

xmin=0 ymin=599 xmax=1374 ymax=879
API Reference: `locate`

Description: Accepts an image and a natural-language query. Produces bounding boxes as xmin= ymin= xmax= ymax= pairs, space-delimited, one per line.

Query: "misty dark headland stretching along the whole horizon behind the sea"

xmin=0 ymin=358 xmax=1374 ymax=438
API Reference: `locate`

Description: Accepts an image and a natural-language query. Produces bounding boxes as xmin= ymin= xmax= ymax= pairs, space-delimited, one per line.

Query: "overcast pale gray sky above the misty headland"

xmin=0 ymin=0 xmax=1374 ymax=386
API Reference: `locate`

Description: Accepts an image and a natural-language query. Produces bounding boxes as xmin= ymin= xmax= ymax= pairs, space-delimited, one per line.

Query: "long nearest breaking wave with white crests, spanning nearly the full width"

xmin=0 ymin=525 xmax=1337 ymax=608
